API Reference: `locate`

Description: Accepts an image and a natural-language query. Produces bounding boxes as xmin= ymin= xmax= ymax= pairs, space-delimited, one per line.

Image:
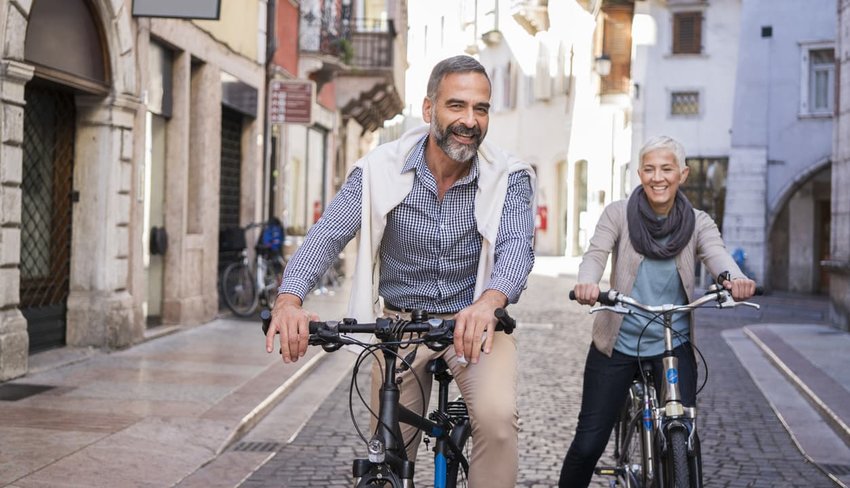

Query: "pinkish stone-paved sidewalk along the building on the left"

xmin=0 ymin=282 xmax=348 ymax=488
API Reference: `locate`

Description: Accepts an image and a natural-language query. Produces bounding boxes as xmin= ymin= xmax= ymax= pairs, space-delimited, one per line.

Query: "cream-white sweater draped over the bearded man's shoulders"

xmin=348 ymin=125 xmax=536 ymax=322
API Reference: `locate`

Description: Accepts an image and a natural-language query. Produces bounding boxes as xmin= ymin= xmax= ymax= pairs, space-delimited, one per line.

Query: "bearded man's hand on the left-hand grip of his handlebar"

xmin=266 ymin=293 xmax=319 ymax=363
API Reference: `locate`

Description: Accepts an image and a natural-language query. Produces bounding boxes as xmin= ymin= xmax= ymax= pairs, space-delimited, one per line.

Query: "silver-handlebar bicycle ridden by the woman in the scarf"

xmin=570 ymin=272 xmax=762 ymax=488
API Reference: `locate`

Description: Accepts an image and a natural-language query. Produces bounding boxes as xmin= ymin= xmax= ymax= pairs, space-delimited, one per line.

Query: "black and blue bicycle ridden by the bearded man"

xmin=260 ymin=309 xmax=516 ymax=488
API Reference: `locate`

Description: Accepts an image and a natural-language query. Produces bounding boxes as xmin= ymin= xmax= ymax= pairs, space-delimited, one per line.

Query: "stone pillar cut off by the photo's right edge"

xmin=827 ymin=0 xmax=850 ymax=330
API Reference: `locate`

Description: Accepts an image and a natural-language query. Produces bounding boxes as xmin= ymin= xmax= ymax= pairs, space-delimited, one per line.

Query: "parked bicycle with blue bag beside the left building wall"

xmin=221 ymin=219 xmax=286 ymax=317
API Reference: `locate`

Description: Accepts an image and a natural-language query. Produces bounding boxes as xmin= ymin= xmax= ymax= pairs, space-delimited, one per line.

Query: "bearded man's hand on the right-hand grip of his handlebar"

xmin=454 ymin=290 xmax=508 ymax=364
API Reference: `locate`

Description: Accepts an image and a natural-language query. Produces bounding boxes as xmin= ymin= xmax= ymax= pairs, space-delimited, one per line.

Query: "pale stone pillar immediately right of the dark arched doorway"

xmin=67 ymin=96 xmax=138 ymax=348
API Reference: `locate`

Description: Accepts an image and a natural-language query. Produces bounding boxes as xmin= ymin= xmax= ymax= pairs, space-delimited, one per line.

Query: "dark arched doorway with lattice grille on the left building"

xmin=20 ymin=0 xmax=109 ymax=352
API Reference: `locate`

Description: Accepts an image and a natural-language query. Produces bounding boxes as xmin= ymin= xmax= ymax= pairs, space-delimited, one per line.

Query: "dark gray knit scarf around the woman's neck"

xmin=626 ymin=186 xmax=696 ymax=259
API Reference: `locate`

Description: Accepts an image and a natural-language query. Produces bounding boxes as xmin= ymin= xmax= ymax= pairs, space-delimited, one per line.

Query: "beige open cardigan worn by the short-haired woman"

xmin=578 ymin=200 xmax=745 ymax=356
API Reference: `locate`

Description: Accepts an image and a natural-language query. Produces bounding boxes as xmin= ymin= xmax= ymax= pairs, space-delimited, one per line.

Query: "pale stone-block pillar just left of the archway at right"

xmin=723 ymin=147 xmax=769 ymax=285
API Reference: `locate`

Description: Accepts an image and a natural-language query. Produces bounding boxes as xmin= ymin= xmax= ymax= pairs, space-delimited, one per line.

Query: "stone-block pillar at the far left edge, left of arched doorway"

xmin=0 ymin=60 xmax=33 ymax=381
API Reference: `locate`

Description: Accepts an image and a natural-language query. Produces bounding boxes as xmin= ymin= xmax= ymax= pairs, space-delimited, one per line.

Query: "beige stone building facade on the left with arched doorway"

xmin=0 ymin=0 xmax=267 ymax=380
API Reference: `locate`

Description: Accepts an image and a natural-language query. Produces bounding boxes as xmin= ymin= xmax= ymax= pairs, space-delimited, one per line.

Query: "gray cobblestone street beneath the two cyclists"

xmin=242 ymin=275 xmax=834 ymax=488
